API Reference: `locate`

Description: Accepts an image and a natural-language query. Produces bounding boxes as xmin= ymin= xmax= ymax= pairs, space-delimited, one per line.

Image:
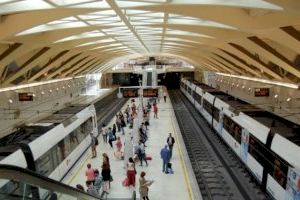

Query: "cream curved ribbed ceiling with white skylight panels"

xmin=0 ymin=0 xmax=300 ymax=87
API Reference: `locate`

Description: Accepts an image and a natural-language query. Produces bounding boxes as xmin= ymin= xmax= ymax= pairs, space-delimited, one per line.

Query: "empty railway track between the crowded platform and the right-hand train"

xmin=169 ymin=90 xmax=270 ymax=200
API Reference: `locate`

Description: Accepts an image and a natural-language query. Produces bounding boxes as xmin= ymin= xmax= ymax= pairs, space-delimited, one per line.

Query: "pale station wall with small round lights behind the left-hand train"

xmin=0 ymin=78 xmax=85 ymax=138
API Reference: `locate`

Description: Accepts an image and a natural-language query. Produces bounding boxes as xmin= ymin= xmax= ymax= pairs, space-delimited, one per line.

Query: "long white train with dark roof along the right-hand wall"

xmin=180 ymin=78 xmax=300 ymax=200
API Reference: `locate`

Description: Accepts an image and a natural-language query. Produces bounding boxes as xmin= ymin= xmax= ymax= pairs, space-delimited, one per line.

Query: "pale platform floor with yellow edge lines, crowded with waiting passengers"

xmin=64 ymin=94 xmax=201 ymax=200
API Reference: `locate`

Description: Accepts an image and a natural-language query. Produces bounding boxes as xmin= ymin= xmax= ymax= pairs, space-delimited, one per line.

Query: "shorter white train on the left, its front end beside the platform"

xmin=0 ymin=104 xmax=98 ymax=198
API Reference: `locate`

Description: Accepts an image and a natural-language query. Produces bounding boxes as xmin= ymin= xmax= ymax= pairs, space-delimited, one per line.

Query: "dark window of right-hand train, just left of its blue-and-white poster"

xmin=223 ymin=115 xmax=242 ymax=143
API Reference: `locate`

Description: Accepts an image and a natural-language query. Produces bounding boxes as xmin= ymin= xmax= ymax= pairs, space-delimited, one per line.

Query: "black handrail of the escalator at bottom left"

xmin=0 ymin=164 xmax=101 ymax=200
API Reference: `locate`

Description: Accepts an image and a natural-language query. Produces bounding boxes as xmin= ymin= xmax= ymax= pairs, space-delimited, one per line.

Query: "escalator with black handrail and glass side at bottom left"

xmin=0 ymin=165 xmax=135 ymax=200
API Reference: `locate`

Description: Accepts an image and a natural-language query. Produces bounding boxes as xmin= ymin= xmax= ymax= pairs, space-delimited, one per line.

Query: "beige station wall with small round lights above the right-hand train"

xmin=204 ymin=75 xmax=300 ymax=124
